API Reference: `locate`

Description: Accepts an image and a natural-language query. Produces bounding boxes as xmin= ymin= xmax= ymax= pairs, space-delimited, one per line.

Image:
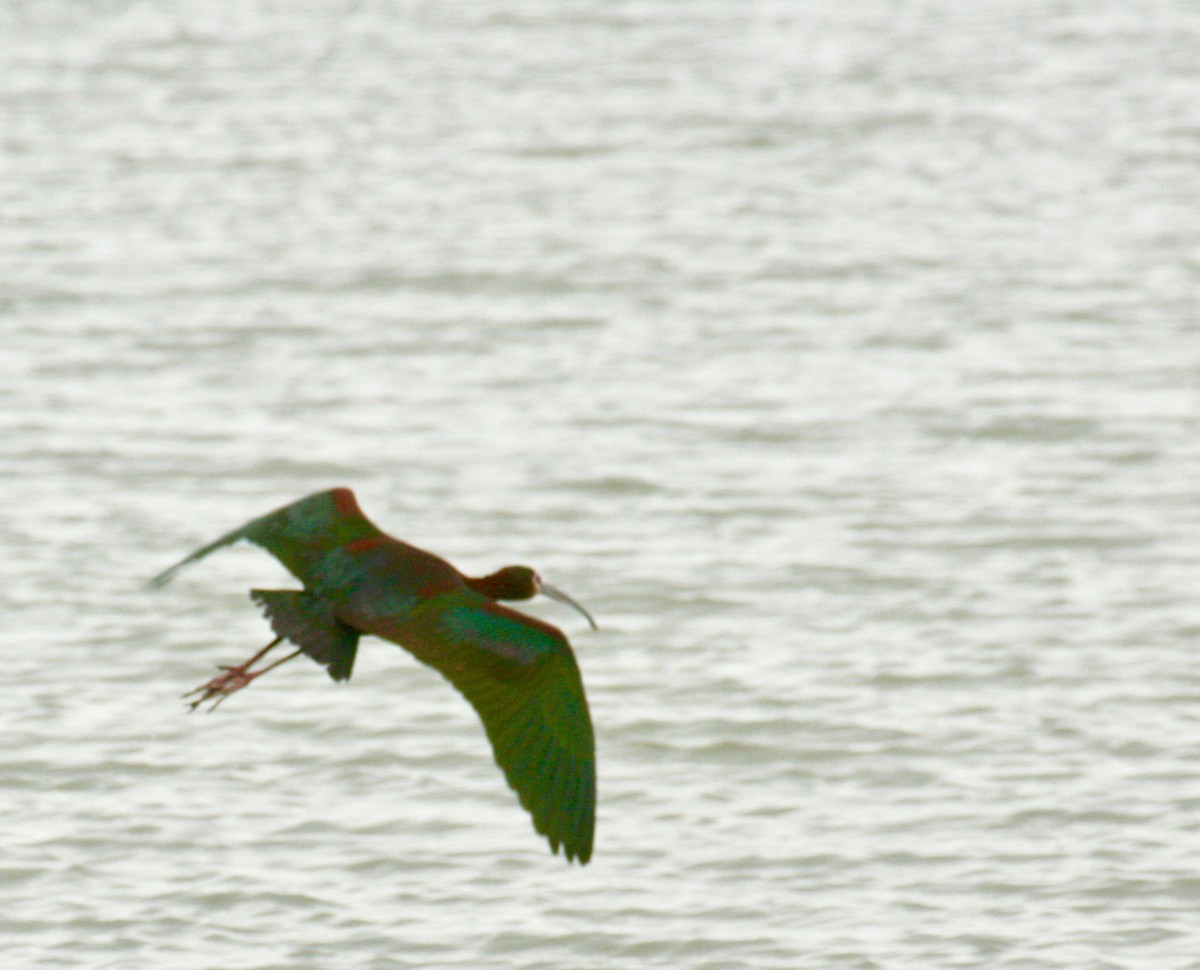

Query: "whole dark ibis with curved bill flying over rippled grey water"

xmin=151 ymin=489 xmax=596 ymax=863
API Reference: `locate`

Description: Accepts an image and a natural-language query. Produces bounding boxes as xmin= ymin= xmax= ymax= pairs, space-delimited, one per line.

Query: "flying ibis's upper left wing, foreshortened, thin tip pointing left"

xmin=150 ymin=489 xmax=383 ymax=588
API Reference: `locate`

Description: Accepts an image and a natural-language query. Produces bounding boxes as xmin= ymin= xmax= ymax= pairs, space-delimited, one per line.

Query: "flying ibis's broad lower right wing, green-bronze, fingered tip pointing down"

xmin=355 ymin=589 xmax=596 ymax=863
